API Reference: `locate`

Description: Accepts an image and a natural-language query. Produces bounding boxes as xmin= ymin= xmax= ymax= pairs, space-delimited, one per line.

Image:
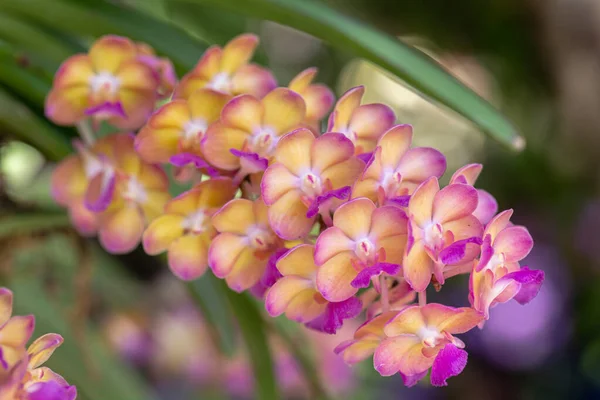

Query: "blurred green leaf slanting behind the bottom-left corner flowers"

xmin=10 ymin=276 xmax=154 ymax=400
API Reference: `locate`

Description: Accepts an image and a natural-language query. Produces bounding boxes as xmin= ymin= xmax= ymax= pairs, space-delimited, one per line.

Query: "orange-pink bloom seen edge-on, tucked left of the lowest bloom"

xmin=334 ymin=311 xmax=398 ymax=365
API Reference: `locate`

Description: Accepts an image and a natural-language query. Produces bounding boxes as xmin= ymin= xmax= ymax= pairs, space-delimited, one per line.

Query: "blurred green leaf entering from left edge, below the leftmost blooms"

xmin=0 ymin=213 xmax=71 ymax=239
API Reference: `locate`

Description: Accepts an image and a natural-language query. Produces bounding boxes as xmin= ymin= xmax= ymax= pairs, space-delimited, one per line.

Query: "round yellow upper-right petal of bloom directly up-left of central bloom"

xmin=262 ymin=88 xmax=306 ymax=135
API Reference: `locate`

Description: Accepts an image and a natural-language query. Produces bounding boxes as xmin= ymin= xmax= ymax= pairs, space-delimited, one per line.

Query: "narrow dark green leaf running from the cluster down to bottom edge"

xmin=219 ymin=282 xmax=279 ymax=400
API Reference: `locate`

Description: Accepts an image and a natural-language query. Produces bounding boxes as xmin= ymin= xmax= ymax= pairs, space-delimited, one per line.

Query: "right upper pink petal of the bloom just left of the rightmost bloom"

xmin=432 ymin=184 xmax=478 ymax=224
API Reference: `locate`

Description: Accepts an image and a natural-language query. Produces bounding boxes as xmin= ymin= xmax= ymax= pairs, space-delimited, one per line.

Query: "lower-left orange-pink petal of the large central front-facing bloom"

xmin=269 ymin=190 xmax=315 ymax=240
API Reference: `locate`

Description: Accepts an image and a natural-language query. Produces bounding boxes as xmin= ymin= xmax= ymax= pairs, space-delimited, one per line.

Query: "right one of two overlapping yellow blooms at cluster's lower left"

xmin=94 ymin=134 xmax=171 ymax=254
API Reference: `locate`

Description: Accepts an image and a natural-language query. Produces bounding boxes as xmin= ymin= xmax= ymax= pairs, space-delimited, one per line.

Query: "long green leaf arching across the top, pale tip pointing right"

xmin=185 ymin=0 xmax=525 ymax=150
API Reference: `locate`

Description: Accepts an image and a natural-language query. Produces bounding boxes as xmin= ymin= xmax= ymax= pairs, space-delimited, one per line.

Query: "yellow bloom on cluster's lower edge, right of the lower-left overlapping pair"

xmin=143 ymin=178 xmax=236 ymax=280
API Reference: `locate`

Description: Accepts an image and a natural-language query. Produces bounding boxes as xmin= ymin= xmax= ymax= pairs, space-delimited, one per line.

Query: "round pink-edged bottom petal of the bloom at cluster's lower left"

xmin=99 ymin=205 xmax=144 ymax=254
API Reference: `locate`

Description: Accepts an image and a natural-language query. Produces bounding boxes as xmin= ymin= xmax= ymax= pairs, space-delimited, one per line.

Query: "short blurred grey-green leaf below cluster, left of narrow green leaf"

xmin=187 ymin=274 xmax=236 ymax=355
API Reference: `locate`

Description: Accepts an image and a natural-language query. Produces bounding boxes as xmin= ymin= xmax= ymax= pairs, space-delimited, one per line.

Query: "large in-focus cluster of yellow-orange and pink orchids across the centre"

xmin=46 ymin=34 xmax=544 ymax=386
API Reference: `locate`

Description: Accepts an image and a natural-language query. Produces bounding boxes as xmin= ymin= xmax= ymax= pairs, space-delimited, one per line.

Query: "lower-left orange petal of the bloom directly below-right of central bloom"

xmin=317 ymin=251 xmax=358 ymax=302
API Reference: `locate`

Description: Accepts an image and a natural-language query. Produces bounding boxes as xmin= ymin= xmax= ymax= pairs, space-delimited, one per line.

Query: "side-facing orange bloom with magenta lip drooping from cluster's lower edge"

xmin=265 ymin=244 xmax=362 ymax=334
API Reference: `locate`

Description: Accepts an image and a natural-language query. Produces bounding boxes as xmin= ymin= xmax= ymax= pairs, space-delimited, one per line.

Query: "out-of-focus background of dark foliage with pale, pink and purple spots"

xmin=0 ymin=0 xmax=600 ymax=400
